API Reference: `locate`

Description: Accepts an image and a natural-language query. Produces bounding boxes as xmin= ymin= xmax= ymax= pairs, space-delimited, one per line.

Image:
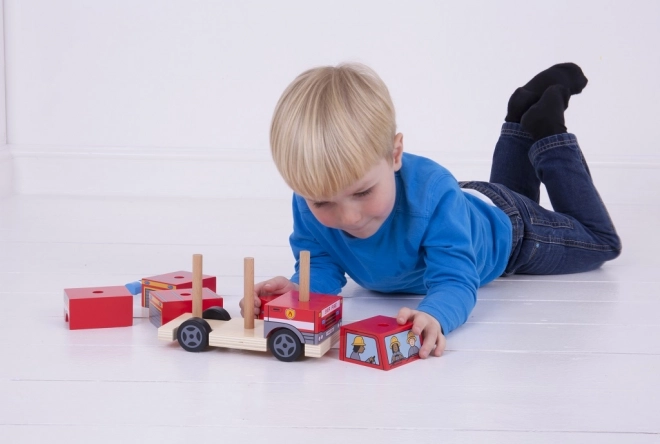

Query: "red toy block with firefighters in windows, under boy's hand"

xmin=339 ymin=316 xmax=422 ymax=370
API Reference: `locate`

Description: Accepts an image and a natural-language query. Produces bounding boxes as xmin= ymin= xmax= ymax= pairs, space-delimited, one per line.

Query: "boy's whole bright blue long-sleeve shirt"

xmin=290 ymin=153 xmax=512 ymax=334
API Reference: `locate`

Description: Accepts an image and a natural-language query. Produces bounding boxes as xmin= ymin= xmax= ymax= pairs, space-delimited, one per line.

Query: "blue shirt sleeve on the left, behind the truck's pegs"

xmin=289 ymin=195 xmax=346 ymax=294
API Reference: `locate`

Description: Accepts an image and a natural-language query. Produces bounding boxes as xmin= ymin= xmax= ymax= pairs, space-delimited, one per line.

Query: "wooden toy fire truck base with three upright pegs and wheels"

xmin=158 ymin=251 xmax=342 ymax=362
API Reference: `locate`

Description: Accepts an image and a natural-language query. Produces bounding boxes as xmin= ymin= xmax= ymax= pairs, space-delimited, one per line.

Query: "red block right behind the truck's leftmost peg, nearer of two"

xmin=149 ymin=288 xmax=223 ymax=327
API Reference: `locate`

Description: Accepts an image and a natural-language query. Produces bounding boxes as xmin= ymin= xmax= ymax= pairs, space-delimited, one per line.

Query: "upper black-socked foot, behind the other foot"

xmin=504 ymin=63 xmax=588 ymax=123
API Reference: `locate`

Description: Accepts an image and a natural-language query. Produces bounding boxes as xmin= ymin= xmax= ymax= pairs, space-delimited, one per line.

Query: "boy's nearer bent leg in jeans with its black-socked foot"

xmin=510 ymin=85 xmax=621 ymax=274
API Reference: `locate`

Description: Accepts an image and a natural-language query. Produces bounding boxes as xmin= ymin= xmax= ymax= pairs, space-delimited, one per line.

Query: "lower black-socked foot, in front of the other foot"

xmin=520 ymin=85 xmax=571 ymax=141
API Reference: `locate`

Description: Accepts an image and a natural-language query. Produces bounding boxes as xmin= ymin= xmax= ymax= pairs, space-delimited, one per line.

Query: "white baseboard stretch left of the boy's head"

xmin=12 ymin=145 xmax=291 ymax=198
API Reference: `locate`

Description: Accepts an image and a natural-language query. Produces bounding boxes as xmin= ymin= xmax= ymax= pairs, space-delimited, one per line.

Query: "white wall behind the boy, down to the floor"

xmin=5 ymin=0 xmax=660 ymax=198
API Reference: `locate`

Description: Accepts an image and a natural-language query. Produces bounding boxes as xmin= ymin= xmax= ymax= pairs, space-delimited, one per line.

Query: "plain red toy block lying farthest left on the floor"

xmin=64 ymin=285 xmax=133 ymax=330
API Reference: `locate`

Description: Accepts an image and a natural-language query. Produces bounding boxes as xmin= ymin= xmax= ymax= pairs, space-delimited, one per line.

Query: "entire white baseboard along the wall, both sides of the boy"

xmin=6 ymin=145 xmax=660 ymax=204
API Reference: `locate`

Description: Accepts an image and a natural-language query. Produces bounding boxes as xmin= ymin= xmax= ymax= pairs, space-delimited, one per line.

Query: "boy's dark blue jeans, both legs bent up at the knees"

xmin=461 ymin=123 xmax=621 ymax=276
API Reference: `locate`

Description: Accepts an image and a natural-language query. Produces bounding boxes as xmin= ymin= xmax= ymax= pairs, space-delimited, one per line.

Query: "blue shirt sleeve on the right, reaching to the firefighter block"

xmin=418 ymin=180 xmax=480 ymax=334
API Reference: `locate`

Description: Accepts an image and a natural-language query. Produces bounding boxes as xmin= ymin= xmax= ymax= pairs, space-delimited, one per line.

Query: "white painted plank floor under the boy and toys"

xmin=0 ymin=196 xmax=660 ymax=444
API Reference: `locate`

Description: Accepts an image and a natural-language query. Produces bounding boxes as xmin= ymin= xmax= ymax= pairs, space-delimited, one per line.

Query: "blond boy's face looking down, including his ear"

xmin=307 ymin=134 xmax=403 ymax=239
